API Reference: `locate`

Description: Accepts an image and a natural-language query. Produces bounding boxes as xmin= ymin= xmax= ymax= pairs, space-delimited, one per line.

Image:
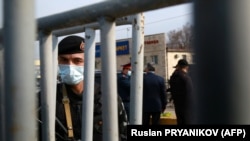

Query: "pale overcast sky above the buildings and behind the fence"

xmin=0 ymin=0 xmax=193 ymax=58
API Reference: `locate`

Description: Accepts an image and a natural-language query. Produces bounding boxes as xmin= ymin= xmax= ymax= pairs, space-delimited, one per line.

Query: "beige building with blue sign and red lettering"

xmin=95 ymin=33 xmax=167 ymax=78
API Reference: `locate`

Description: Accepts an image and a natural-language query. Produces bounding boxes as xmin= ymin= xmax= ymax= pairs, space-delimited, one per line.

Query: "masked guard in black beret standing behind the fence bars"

xmin=38 ymin=35 xmax=127 ymax=141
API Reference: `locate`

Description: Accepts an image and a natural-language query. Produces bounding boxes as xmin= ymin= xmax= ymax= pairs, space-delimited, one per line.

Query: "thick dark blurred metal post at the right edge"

xmin=194 ymin=0 xmax=250 ymax=124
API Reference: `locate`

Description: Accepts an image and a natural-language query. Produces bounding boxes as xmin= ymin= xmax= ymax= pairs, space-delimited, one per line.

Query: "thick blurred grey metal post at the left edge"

xmin=3 ymin=0 xmax=37 ymax=141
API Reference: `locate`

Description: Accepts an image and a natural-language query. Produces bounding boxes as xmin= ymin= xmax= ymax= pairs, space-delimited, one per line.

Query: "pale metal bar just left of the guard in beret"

xmin=39 ymin=32 xmax=55 ymax=141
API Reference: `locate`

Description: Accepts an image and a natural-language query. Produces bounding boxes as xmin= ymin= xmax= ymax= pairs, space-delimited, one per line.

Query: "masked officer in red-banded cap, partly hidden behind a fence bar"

xmin=117 ymin=63 xmax=131 ymax=119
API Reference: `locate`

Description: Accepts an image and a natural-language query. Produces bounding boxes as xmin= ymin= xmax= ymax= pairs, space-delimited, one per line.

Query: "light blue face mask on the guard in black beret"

xmin=59 ymin=65 xmax=84 ymax=85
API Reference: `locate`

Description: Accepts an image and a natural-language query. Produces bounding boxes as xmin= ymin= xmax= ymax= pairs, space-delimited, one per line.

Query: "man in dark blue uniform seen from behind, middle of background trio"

xmin=142 ymin=63 xmax=167 ymax=125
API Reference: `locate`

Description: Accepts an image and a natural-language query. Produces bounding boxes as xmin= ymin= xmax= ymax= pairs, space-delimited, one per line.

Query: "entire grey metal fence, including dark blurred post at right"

xmin=0 ymin=0 xmax=250 ymax=141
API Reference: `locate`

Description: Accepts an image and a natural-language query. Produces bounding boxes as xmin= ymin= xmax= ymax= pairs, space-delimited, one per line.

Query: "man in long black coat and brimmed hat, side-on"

xmin=169 ymin=59 xmax=193 ymax=125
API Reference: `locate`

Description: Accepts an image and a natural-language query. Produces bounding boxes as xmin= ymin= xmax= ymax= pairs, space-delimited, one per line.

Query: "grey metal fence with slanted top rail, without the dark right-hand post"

xmin=0 ymin=0 xmax=186 ymax=141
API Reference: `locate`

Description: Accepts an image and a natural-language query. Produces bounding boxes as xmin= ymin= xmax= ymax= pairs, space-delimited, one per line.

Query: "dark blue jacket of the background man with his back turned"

xmin=143 ymin=72 xmax=167 ymax=112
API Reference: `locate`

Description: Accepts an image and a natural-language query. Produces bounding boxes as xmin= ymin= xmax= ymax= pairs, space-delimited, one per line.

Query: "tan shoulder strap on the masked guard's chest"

xmin=62 ymin=84 xmax=74 ymax=138
